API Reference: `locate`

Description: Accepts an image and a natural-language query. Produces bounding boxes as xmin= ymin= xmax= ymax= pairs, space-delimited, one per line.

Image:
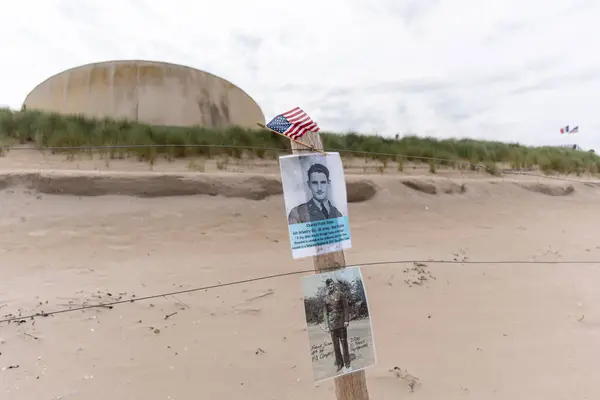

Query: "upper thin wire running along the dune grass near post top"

xmin=0 ymin=144 xmax=600 ymax=183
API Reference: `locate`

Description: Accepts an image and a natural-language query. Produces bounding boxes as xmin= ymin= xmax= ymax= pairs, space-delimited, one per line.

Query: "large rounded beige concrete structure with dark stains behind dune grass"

xmin=24 ymin=61 xmax=265 ymax=128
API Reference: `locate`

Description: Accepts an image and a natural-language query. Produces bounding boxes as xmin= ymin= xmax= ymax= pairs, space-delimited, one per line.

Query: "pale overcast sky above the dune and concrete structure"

xmin=0 ymin=0 xmax=600 ymax=150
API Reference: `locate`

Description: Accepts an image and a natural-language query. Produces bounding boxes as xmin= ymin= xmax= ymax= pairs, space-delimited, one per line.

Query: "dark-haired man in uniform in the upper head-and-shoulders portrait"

xmin=288 ymin=164 xmax=342 ymax=225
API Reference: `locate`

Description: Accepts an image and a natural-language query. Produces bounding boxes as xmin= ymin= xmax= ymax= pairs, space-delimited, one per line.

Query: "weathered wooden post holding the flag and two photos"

xmin=290 ymin=132 xmax=369 ymax=400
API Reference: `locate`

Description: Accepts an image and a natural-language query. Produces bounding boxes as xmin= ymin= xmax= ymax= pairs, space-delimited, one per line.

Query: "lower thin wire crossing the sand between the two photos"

xmin=0 ymin=260 xmax=600 ymax=323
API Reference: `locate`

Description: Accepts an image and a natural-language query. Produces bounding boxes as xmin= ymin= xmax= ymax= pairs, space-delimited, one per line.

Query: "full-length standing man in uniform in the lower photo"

xmin=323 ymin=278 xmax=350 ymax=373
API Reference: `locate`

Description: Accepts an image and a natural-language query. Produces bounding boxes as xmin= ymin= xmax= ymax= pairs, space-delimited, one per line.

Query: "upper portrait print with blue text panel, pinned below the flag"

xmin=279 ymin=152 xmax=352 ymax=258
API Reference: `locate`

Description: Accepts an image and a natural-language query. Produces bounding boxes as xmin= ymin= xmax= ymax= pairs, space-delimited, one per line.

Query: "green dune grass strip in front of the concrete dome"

xmin=0 ymin=109 xmax=600 ymax=175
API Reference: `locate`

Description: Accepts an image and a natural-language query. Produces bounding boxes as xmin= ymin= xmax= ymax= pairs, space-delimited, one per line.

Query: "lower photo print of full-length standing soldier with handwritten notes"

xmin=302 ymin=267 xmax=375 ymax=381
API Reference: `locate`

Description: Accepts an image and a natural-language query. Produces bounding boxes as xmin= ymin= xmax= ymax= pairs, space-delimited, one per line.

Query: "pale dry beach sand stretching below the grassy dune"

xmin=0 ymin=155 xmax=600 ymax=400
